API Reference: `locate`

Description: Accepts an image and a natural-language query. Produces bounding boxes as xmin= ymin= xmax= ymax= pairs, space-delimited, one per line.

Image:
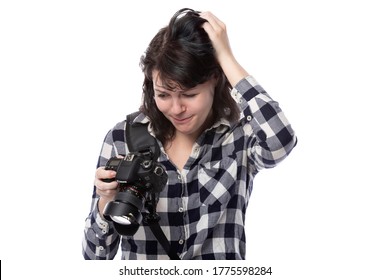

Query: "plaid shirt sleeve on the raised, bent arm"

xmin=232 ymin=76 xmax=297 ymax=171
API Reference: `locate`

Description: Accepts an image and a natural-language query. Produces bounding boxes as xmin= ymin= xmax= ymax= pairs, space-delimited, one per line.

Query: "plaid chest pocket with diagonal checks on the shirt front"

xmin=198 ymin=156 xmax=237 ymax=208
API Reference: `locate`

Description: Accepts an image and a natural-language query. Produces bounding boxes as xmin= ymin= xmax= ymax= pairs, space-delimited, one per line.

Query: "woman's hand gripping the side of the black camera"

xmin=95 ymin=167 xmax=118 ymax=214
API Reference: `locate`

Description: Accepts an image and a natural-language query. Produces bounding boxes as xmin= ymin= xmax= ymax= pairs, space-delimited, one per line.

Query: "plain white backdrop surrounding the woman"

xmin=0 ymin=0 xmax=390 ymax=279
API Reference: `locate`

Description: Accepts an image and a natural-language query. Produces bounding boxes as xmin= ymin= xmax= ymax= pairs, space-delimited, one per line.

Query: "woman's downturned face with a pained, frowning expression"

xmin=153 ymin=71 xmax=215 ymax=139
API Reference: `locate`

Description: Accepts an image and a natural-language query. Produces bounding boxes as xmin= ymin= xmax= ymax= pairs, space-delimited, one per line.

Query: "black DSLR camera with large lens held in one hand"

xmin=103 ymin=152 xmax=168 ymax=235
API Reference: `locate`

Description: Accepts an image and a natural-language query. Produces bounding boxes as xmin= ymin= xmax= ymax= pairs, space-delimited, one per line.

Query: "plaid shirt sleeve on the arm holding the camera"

xmin=82 ymin=122 xmax=126 ymax=260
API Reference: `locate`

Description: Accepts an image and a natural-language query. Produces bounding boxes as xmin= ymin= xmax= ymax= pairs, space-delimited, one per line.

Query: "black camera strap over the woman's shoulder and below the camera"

xmin=125 ymin=111 xmax=180 ymax=260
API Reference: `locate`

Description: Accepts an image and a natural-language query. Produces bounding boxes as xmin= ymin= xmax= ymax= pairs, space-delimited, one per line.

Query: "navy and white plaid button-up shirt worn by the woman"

xmin=83 ymin=76 xmax=296 ymax=259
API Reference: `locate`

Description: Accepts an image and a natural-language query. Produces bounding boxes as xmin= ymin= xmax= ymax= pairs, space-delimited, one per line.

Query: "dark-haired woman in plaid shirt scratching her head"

xmin=83 ymin=9 xmax=296 ymax=259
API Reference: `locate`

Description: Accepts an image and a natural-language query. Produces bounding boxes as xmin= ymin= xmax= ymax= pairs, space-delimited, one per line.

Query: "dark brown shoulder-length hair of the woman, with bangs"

xmin=140 ymin=8 xmax=239 ymax=143
